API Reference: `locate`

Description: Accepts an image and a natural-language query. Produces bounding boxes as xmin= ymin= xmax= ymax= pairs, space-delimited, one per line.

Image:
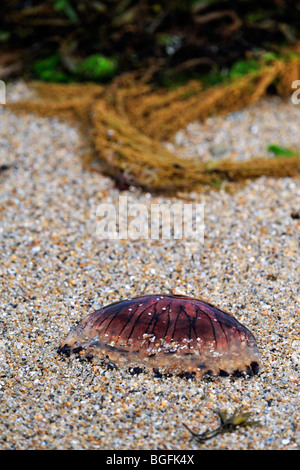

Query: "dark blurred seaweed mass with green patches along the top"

xmin=0 ymin=0 xmax=300 ymax=86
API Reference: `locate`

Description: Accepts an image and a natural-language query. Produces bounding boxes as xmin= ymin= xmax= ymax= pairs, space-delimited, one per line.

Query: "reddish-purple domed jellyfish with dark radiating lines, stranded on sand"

xmin=58 ymin=295 xmax=260 ymax=377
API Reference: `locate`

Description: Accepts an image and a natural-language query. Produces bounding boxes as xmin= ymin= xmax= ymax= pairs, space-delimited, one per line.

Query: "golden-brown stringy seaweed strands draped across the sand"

xmin=8 ymin=48 xmax=300 ymax=194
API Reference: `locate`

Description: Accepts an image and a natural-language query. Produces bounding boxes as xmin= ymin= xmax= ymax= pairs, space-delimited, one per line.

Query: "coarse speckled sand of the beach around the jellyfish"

xmin=0 ymin=83 xmax=300 ymax=450
